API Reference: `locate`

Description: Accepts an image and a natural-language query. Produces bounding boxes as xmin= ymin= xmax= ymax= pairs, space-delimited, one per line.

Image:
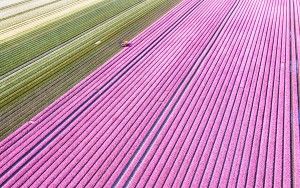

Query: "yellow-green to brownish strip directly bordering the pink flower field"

xmin=0 ymin=0 xmax=180 ymax=140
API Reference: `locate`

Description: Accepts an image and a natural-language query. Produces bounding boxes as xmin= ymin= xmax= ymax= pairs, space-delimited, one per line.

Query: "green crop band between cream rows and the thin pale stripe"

xmin=0 ymin=0 xmax=141 ymax=76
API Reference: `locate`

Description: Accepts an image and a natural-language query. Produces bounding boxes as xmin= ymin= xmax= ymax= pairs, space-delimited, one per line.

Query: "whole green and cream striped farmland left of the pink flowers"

xmin=0 ymin=0 xmax=179 ymax=139
